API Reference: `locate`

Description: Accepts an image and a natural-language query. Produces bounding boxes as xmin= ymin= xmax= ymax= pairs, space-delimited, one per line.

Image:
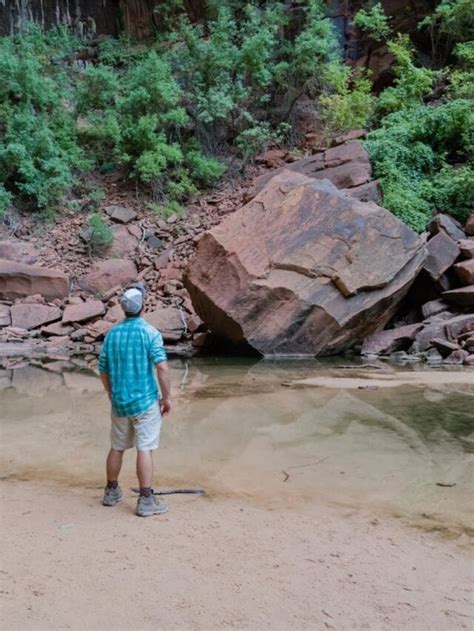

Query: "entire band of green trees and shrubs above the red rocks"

xmin=0 ymin=0 xmax=474 ymax=230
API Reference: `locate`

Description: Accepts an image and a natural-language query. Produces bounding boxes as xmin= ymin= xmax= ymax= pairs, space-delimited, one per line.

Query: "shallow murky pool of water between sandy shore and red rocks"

xmin=0 ymin=358 xmax=474 ymax=532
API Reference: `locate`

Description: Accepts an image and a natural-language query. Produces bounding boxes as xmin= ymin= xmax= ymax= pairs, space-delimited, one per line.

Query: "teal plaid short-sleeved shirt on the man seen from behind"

xmin=99 ymin=317 xmax=166 ymax=416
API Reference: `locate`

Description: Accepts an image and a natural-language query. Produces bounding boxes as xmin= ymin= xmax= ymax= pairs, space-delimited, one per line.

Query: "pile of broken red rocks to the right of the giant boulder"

xmin=361 ymin=214 xmax=474 ymax=366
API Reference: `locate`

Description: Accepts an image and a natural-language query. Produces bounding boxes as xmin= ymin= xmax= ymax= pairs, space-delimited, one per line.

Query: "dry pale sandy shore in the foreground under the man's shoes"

xmin=0 ymin=482 xmax=474 ymax=631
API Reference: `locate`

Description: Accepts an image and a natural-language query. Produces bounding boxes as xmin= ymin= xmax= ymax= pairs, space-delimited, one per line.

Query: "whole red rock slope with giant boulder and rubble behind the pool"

xmin=0 ymin=130 xmax=474 ymax=369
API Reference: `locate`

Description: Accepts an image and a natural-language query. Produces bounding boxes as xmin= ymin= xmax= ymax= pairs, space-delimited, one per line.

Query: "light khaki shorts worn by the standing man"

xmin=110 ymin=402 xmax=161 ymax=451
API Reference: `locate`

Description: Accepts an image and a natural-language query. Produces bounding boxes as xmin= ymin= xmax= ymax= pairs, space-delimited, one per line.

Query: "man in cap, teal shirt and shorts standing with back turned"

xmin=99 ymin=283 xmax=171 ymax=517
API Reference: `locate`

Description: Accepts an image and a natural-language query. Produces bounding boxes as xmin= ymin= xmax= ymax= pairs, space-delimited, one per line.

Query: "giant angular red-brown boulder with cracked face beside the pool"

xmin=185 ymin=170 xmax=426 ymax=356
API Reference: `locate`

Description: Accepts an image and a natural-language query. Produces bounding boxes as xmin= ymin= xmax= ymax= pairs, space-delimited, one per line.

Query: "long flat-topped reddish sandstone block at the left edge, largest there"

xmin=0 ymin=259 xmax=69 ymax=300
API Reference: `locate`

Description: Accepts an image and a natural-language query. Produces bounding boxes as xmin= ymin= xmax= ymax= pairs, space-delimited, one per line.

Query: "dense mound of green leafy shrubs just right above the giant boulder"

xmin=366 ymin=99 xmax=474 ymax=231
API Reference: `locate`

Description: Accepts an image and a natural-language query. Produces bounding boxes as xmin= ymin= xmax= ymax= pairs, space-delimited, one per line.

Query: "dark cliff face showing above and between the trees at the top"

xmin=0 ymin=0 xmax=438 ymax=85
